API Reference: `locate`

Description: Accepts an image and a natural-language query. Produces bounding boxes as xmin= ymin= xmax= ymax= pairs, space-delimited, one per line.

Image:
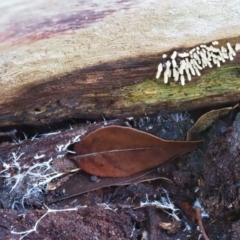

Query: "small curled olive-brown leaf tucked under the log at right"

xmin=187 ymin=104 xmax=239 ymax=141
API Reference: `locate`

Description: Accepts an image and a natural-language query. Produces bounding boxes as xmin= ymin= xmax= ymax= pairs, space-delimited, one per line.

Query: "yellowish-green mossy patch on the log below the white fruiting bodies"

xmin=118 ymin=64 xmax=240 ymax=107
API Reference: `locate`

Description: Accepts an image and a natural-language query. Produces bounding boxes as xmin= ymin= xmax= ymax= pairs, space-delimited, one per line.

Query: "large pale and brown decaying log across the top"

xmin=0 ymin=0 xmax=240 ymax=126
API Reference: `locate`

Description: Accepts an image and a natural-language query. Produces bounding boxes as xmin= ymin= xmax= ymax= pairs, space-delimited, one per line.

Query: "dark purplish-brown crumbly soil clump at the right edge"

xmin=202 ymin=111 xmax=240 ymax=218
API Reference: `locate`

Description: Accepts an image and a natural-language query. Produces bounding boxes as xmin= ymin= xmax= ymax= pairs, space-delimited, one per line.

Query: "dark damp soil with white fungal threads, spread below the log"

xmin=0 ymin=111 xmax=240 ymax=240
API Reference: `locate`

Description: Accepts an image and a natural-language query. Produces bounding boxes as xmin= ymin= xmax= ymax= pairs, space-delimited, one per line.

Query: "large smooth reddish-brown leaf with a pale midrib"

xmin=71 ymin=126 xmax=201 ymax=177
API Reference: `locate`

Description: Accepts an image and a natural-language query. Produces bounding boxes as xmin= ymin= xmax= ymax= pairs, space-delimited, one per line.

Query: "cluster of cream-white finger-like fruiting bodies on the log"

xmin=156 ymin=41 xmax=240 ymax=85
